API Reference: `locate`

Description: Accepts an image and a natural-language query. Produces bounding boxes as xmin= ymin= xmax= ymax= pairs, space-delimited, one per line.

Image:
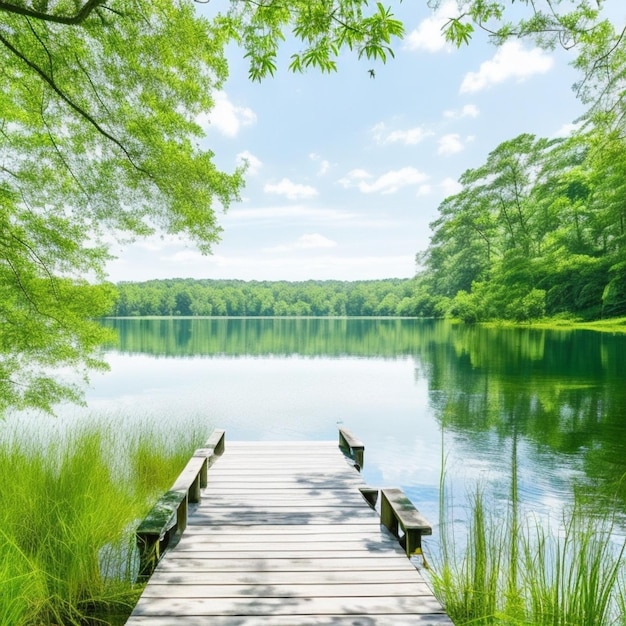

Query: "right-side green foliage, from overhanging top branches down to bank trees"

xmin=418 ymin=0 xmax=626 ymax=321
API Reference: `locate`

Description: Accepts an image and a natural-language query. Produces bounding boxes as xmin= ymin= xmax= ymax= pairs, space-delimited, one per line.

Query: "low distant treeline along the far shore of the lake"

xmin=111 ymin=278 xmax=418 ymax=317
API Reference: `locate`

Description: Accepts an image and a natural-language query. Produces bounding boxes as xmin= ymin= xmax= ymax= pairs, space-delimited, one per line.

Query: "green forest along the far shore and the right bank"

xmin=112 ymin=42 xmax=626 ymax=322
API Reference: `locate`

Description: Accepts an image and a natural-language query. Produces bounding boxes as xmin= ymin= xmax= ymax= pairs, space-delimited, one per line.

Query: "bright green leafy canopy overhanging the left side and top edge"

xmin=0 ymin=0 xmax=620 ymax=413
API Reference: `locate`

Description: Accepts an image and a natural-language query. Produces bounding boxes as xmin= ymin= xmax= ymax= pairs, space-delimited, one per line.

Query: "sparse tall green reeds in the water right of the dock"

xmin=429 ymin=490 xmax=626 ymax=626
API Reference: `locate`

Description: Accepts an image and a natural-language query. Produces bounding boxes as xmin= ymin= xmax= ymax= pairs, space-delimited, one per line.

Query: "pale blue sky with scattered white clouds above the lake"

xmin=103 ymin=0 xmax=626 ymax=282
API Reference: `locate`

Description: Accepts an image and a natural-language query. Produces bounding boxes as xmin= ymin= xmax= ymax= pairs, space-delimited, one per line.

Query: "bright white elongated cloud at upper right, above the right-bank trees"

xmin=460 ymin=41 xmax=554 ymax=93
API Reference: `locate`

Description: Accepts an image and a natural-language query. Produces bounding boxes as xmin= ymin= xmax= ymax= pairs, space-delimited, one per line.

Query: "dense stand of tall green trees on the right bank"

xmin=407 ymin=128 xmax=626 ymax=322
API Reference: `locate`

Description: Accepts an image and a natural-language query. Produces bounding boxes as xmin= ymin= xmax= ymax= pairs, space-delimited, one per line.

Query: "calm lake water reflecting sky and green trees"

xmin=22 ymin=319 xmax=626 ymax=541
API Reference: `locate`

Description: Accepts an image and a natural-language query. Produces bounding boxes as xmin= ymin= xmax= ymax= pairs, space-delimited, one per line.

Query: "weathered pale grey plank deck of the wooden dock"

xmin=127 ymin=428 xmax=452 ymax=626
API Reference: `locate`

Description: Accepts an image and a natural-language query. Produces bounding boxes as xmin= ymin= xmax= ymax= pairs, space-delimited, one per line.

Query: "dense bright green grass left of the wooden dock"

xmin=0 ymin=422 xmax=207 ymax=626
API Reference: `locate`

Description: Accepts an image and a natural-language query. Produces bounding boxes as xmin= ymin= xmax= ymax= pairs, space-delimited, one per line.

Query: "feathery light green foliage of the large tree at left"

xmin=0 ymin=0 xmax=242 ymax=414
